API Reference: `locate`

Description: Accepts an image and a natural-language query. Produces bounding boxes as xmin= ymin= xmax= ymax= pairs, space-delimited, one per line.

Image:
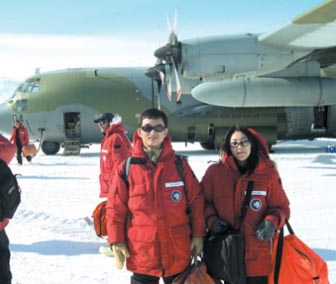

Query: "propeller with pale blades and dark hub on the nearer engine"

xmin=154 ymin=13 xmax=182 ymax=102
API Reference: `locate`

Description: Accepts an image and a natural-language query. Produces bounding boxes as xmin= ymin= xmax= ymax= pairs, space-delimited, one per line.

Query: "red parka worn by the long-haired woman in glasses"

xmin=202 ymin=131 xmax=290 ymax=277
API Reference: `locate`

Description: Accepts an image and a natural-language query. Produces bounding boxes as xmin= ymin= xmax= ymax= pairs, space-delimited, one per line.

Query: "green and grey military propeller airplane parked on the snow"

xmin=0 ymin=0 xmax=336 ymax=154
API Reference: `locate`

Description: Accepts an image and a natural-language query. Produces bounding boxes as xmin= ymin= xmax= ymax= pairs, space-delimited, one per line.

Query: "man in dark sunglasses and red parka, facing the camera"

xmin=106 ymin=108 xmax=205 ymax=284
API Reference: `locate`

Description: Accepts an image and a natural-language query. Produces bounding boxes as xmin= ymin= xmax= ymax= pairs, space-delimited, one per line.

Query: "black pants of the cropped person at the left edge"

xmin=0 ymin=230 xmax=12 ymax=284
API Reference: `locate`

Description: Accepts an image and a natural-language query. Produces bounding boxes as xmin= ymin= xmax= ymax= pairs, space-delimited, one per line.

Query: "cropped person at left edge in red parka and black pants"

xmin=0 ymin=134 xmax=16 ymax=284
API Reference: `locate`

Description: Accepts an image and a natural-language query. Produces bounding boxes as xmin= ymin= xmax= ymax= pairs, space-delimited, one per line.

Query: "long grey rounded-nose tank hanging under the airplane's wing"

xmin=191 ymin=77 xmax=336 ymax=107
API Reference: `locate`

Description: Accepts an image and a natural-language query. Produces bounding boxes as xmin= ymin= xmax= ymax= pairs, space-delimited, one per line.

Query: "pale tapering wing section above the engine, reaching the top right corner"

xmin=258 ymin=0 xmax=336 ymax=49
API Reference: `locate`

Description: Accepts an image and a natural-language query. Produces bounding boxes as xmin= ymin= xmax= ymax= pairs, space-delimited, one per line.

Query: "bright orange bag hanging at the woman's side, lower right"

xmin=268 ymin=221 xmax=329 ymax=284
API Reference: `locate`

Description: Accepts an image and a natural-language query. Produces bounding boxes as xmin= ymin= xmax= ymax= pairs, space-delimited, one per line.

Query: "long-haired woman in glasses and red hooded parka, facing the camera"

xmin=201 ymin=127 xmax=290 ymax=284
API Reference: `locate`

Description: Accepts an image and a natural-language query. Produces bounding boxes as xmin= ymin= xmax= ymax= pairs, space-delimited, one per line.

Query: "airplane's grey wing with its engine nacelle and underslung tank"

xmin=155 ymin=0 xmax=336 ymax=108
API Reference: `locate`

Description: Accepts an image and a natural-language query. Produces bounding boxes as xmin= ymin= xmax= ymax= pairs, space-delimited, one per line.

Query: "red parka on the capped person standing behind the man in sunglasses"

xmin=99 ymin=124 xmax=132 ymax=197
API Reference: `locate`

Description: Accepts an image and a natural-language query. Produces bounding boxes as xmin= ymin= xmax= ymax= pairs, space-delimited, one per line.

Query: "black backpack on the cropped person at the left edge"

xmin=0 ymin=159 xmax=21 ymax=219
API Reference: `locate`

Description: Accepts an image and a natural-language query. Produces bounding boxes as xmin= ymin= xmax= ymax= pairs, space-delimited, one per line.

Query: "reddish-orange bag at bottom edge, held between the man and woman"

xmin=172 ymin=257 xmax=220 ymax=284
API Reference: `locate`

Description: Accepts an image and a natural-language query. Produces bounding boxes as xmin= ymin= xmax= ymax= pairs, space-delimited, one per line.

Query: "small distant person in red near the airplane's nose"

xmin=9 ymin=120 xmax=32 ymax=165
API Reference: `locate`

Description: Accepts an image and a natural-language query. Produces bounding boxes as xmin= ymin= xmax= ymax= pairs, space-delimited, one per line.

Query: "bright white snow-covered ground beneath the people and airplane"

xmin=7 ymin=139 xmax=336 ymax=284
